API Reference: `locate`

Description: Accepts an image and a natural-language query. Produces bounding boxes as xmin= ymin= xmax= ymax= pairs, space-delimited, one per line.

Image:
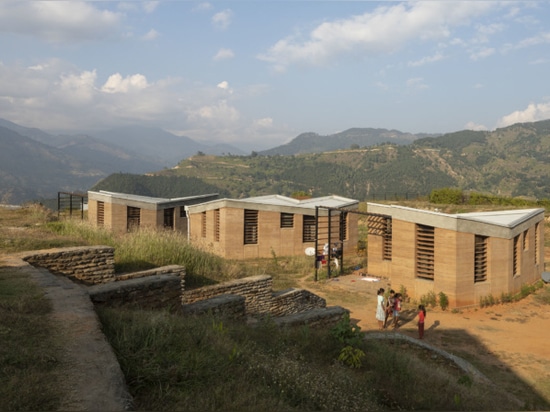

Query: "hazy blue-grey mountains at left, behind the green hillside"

xmin=0 ymin=119 xmax=244 ymax=204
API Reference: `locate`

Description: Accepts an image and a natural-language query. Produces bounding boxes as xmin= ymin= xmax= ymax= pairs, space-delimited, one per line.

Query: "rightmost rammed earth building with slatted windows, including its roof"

xmin=367 ymin=203 xmax=544 ymax=308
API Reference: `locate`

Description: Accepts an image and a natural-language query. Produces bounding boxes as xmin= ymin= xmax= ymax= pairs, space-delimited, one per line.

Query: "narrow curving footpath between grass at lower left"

xmin=3 ymin=255 xmax=132 ymax=412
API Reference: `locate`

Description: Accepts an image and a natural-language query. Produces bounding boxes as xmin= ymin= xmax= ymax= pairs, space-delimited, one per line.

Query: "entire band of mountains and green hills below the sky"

xmin=0 ymin=119 xmax=550 ymax=204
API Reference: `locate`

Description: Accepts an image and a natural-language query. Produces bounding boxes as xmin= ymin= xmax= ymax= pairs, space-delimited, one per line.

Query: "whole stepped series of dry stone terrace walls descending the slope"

xmin=21 ymin=246 xmax=345 ymax=326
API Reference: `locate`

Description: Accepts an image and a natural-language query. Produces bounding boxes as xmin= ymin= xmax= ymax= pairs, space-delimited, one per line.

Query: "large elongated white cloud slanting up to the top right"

xmin=257 ymin=1 xmax=498 ymax=71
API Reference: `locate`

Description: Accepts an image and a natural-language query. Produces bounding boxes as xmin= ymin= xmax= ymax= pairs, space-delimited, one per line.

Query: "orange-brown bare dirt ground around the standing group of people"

xmin=301 ymin=274 xmax=550 ymax=405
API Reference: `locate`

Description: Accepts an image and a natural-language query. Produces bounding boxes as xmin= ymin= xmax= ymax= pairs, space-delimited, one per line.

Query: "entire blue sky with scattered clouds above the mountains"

xmin=0 ymin=0 xmax=550 ymax=149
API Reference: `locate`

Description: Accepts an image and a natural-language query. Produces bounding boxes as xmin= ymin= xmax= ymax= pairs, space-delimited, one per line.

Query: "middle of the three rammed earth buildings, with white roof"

xmin=187 ymin=195 xmax=359 ymax=259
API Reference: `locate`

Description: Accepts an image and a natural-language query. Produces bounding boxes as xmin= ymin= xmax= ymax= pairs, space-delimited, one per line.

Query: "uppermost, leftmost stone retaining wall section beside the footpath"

xmin=22 ymin=246 xmax=115 ymax=285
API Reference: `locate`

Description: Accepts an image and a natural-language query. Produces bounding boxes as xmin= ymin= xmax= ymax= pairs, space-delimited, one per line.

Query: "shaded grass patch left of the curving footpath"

xmin=0 ymin=268 xmax=60 ymax=411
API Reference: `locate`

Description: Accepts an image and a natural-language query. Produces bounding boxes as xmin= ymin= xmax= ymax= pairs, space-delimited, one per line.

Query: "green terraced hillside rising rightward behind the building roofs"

xmin=96 ymin=120 xmax=550 ymax=200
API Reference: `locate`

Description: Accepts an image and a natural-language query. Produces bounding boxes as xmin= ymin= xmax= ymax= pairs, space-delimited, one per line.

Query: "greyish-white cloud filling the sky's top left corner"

xmin=0 ymin=0 xmax=122 ymax=43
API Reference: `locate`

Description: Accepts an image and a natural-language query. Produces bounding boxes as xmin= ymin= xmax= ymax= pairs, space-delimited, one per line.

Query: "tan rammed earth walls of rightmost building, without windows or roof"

xmin=368 ymin=214 xmax=544 ymax=307
